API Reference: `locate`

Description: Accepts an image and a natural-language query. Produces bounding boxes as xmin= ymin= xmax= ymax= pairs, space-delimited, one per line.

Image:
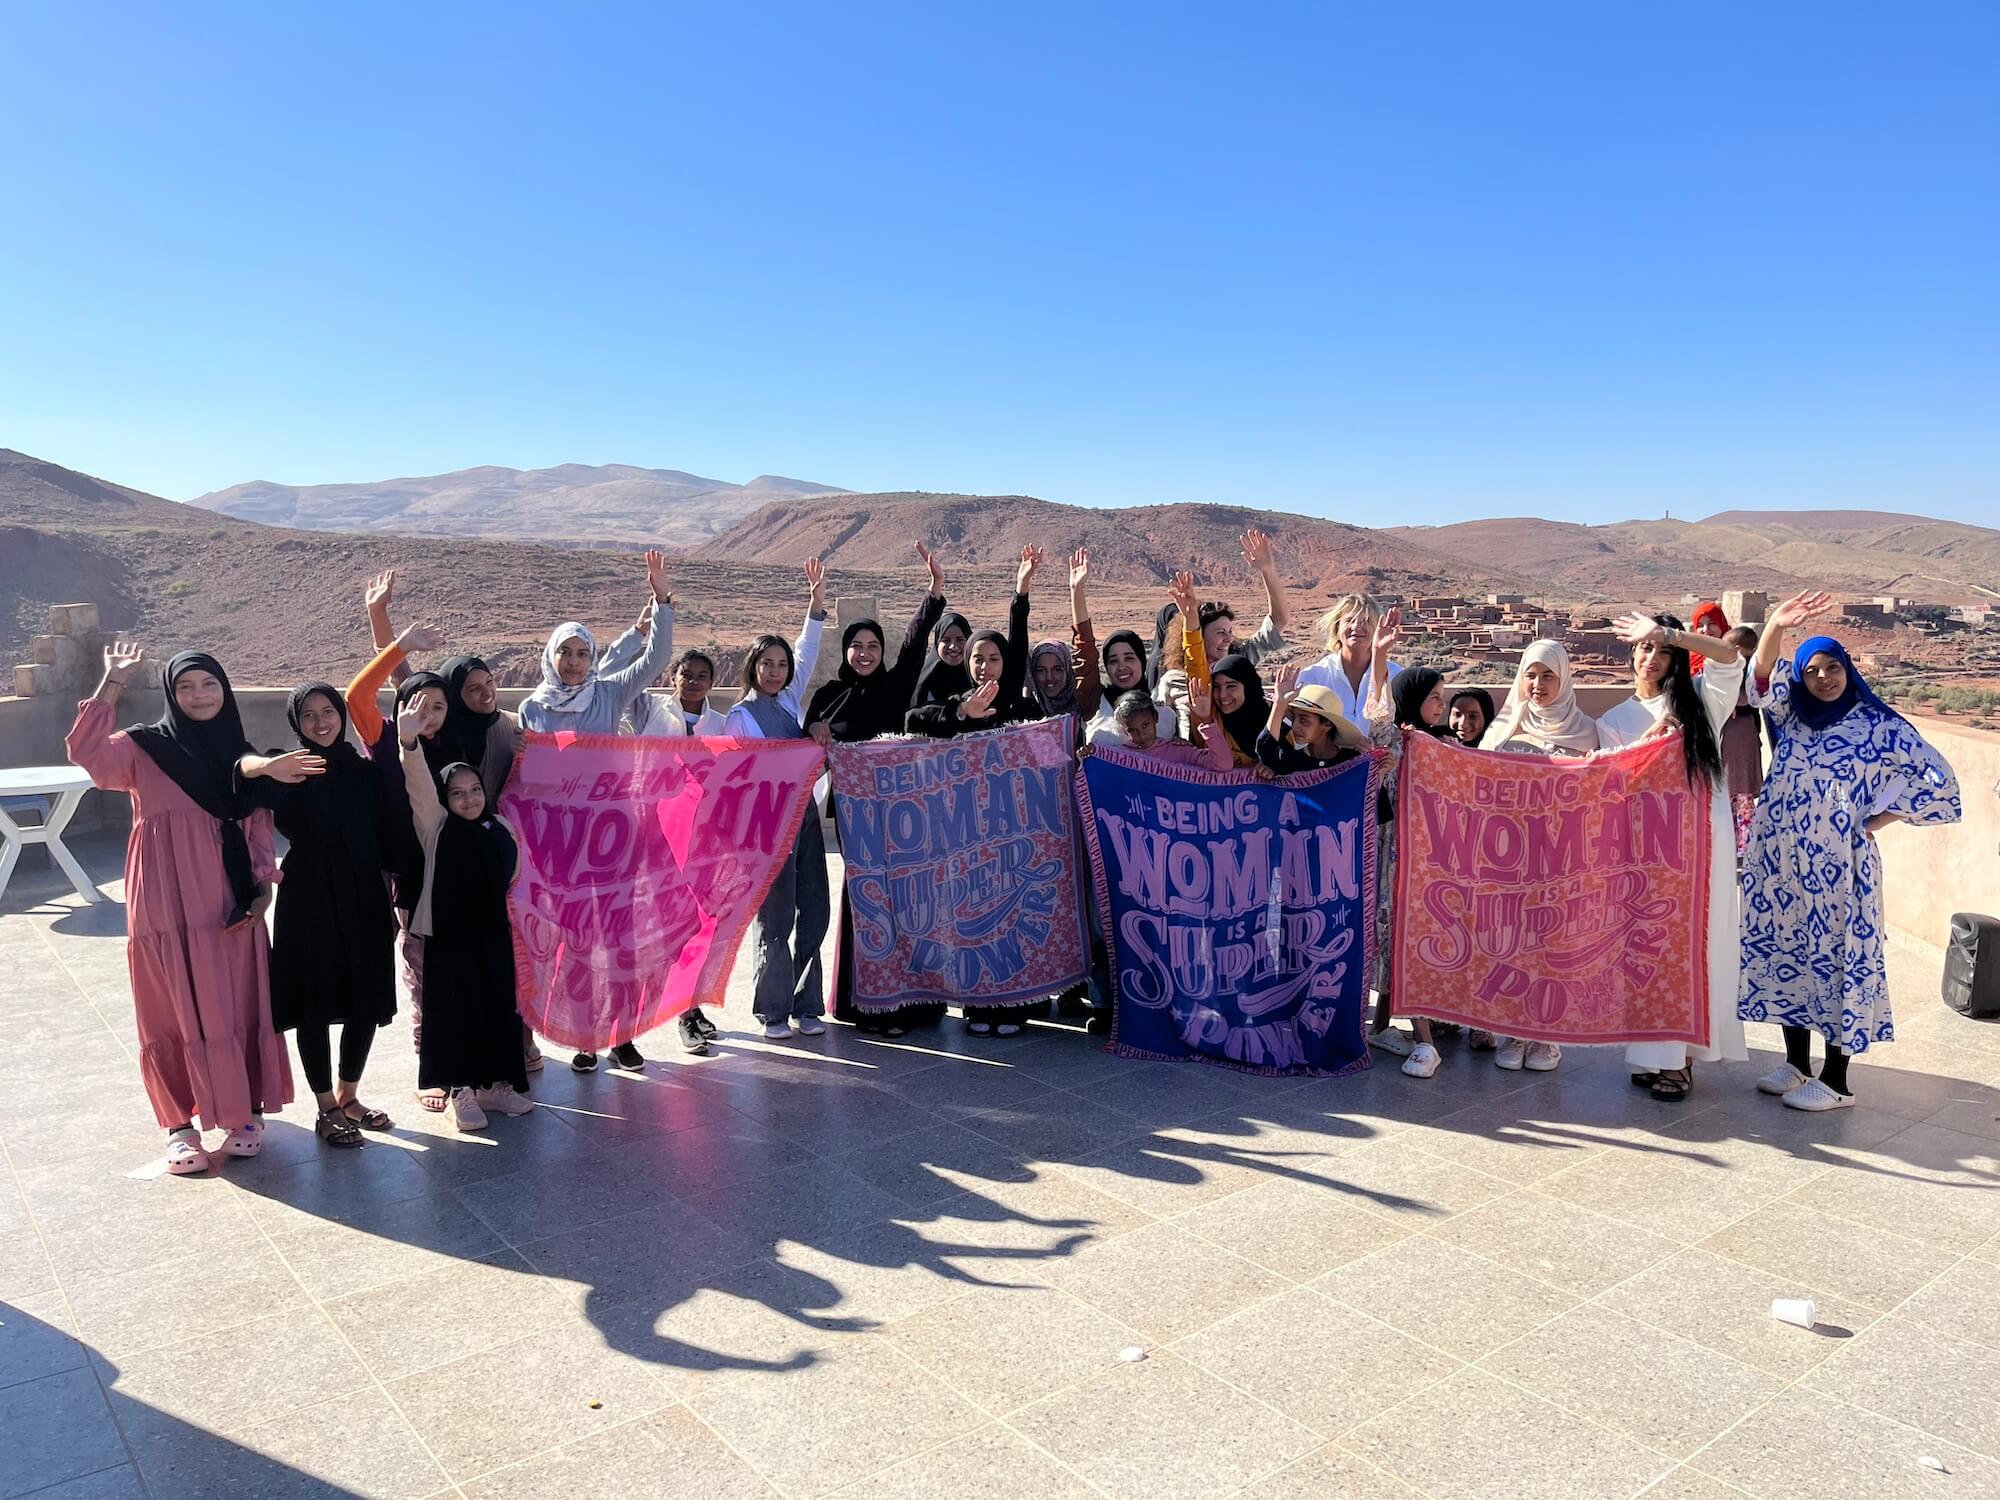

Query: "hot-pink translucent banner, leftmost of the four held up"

xmin=500 ymin=734 xmax=822 ymax=1052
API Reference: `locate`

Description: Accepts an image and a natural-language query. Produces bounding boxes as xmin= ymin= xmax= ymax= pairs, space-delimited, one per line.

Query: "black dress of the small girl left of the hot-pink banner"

xmin=416 ymin=812 xmax=528 ymax=1092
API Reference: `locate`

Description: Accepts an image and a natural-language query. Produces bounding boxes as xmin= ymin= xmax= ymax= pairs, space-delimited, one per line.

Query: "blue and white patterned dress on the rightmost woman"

xmin=1736 ymin=660 xmax=1960 ymax=1052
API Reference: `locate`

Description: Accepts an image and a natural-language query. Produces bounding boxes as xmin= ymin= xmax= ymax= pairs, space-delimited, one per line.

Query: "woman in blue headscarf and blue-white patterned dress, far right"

xmin=1738 ymin=592 xmax=1958 ymax=1110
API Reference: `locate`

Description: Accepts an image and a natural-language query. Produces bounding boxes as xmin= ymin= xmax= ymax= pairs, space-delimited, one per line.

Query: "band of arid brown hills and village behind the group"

xmin=0 ymin=450 xmax=2000 ymax=716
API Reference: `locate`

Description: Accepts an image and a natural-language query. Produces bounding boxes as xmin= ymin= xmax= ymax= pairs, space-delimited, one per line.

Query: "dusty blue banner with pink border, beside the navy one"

xmin=826 ymin=718 xmax=1090 ymax=1012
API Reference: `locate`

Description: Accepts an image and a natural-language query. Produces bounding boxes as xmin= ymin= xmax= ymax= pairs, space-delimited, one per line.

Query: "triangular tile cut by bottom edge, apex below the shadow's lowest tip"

xmin=460 ymin=1406 xmax=778 ymax=1500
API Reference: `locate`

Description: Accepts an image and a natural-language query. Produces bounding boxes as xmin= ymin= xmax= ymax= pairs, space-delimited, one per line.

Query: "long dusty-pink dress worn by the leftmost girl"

xmin=66 ymin=698 xmax=292 ymax=1130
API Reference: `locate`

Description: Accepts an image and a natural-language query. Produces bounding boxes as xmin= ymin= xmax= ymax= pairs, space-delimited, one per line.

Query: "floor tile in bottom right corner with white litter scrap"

xmin=1690 ymin=1386 xmax=2000 ymax=1500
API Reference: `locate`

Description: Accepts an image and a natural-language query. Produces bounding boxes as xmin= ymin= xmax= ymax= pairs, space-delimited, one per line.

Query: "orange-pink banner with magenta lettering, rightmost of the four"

xmin=1392 ymin=734 xmax=1710 ymax=1046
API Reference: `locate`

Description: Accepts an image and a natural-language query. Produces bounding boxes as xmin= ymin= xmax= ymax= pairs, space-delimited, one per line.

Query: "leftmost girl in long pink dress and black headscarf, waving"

xmin=68 ymin=640 xmax=292 ymax=1174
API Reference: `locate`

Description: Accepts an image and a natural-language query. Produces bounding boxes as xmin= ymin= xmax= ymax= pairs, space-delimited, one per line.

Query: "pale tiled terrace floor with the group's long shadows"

xmin=0 ymin=846 xmax=2000 ymax=1500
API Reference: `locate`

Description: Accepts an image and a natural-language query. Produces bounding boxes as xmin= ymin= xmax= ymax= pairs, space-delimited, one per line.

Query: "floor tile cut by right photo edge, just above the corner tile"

xmin=1800 ymin=1318 xmax=2000 ymax=1458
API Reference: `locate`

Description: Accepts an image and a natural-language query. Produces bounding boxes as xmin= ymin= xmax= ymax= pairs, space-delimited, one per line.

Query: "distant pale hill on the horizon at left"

xmin=194 ymin=464 xmax=840 ymax=548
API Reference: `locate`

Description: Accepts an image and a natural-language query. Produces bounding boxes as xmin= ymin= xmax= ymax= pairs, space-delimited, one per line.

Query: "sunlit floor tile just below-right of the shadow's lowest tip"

xmin=690 ymin=1338 xmax=982 ymax=1496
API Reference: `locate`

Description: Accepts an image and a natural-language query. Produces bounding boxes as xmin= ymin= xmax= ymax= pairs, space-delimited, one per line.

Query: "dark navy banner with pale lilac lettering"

xmin=1076 ymin=750 xmax=1382 ymax=1074
